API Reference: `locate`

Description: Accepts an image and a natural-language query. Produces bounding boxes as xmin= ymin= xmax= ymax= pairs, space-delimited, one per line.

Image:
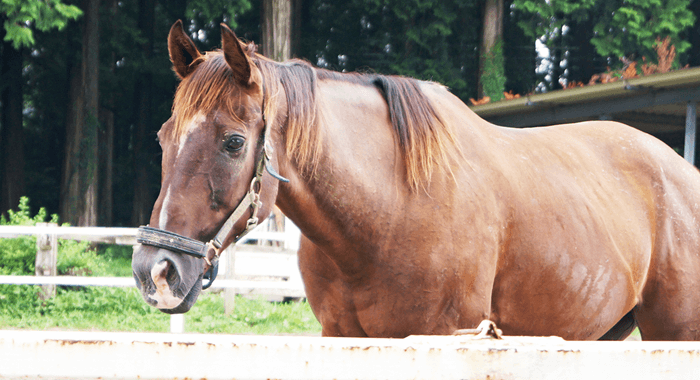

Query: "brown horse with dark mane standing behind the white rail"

xmin=133 ymin=22 xmax=700 ymax=340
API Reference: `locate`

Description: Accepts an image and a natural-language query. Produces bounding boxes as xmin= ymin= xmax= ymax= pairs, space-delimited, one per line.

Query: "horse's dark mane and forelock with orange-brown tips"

xmin=173 ymin=51 xmax=457 ymax=189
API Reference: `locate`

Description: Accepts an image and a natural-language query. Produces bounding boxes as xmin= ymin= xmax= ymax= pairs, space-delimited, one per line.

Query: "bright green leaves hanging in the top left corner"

xmin=0 ymin=0 xmax=83 ymax=50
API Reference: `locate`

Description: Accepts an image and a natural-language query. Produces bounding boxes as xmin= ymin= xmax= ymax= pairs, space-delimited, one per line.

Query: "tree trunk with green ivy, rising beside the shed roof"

xmin=478 ymin=0 xmax=505 ymax=100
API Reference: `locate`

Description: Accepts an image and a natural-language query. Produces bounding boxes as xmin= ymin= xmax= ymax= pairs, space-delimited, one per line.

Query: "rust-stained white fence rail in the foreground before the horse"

xmin=0 ymin=331 xmax=700 ymax=380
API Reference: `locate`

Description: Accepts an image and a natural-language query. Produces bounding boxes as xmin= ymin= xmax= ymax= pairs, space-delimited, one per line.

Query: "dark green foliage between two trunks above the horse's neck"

xmin=307 ymin=0 xmax=479 ymax=99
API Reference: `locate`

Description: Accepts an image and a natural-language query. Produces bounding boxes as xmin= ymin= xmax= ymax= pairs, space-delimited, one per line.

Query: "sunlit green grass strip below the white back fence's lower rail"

xmin=0 ymin=285 xmax=321 ymax=335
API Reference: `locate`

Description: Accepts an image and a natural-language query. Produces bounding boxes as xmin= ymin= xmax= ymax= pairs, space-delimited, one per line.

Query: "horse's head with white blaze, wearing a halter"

xmin=132 ymin=21 xmax=284 ymax=313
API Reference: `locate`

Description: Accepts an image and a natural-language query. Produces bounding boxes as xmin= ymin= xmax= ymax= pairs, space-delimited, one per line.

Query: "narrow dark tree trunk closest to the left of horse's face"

xmin=131 ymin=0 xmax=155 ymax=226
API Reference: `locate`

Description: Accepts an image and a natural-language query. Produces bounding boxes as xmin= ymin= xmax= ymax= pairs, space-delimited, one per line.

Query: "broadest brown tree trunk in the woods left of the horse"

xmin=61 ymin=0 xmax=100 ymax=226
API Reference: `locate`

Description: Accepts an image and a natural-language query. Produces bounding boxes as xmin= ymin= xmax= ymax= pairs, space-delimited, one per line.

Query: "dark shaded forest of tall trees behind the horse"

xmin=0 ymin=0 xmax=700 ymax=226
